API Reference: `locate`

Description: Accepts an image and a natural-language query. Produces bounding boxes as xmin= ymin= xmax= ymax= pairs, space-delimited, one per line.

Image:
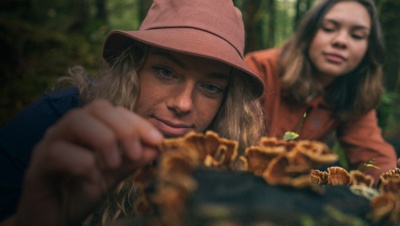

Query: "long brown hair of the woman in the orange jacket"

xmin=278 ymin=0 xmax=384 ymax=120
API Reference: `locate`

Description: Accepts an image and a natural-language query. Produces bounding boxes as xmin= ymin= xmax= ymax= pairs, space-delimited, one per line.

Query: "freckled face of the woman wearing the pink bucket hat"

xmin=135 ymin=48 xmax=231 ymax=137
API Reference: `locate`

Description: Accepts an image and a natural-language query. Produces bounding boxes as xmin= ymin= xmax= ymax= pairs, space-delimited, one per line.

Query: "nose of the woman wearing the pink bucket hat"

xmin=167 ymin=82 xmax=195 ymax=116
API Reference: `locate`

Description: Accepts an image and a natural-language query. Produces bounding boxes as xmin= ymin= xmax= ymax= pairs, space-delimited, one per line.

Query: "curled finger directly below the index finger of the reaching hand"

xmin=45 ymin=109 xmax=121 ymax=168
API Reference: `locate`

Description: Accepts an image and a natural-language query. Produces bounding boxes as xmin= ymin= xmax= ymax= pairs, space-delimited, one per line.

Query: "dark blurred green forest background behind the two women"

xmin=0 ymin=0 xmax=400 ymax=151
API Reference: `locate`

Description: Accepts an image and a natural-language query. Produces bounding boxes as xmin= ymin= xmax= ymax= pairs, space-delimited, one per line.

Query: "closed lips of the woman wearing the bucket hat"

xmin=151 ymin=117 xmax=193 ymax=137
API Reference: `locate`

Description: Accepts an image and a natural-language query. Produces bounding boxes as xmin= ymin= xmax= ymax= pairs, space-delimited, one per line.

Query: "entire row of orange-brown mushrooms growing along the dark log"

xmin=133 ymin=131 xmax=400 ymax=226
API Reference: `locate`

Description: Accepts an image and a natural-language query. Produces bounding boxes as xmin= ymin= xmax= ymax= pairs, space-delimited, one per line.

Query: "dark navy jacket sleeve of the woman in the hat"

xmin=0 ymin=88 xmax=80 ymax=222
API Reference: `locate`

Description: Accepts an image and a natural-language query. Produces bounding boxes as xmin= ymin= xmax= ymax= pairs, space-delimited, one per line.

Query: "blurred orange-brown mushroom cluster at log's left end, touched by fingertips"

xmin=134 ymin=131 xmax=238 ymax=225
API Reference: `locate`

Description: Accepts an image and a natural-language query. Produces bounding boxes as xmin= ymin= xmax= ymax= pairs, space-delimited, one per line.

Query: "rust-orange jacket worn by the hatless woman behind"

xmin=245 ymin=48 xmax=397 ymax=182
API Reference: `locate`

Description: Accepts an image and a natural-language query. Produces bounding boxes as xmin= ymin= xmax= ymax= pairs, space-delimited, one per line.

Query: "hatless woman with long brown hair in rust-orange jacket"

xmin=245 ymin=0 xmax=396 ymax=182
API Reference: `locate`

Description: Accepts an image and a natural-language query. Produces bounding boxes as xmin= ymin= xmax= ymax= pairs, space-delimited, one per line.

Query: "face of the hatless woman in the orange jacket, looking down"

xmin=308 ymin=2 xmax=371 ymax=86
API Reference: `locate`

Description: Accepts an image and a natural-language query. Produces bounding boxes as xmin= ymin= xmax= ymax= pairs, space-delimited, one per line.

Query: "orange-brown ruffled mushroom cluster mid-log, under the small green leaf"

xmin=241 ymin=137 xmax=338 ymax=188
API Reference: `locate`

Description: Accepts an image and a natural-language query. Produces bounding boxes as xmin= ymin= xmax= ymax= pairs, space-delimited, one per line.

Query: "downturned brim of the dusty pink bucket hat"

xmin=103 ymin=28 xmax=264 ymax=98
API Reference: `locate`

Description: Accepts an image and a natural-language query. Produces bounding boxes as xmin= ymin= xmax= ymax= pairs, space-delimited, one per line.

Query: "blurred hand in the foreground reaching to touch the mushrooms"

xmin=16 ymin=101 xmax=163 ymax=225
